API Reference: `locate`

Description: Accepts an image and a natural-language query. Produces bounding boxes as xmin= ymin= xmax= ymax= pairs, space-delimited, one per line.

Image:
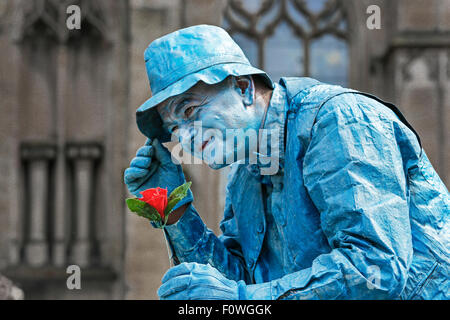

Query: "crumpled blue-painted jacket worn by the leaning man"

xmin=166 ymin=78 xmax=450 ymax=299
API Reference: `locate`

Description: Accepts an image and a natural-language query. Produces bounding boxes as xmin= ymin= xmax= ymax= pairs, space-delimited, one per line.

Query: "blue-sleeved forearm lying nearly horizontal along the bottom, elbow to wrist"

xmin=245 ymin=248 xmax=407 ymax=300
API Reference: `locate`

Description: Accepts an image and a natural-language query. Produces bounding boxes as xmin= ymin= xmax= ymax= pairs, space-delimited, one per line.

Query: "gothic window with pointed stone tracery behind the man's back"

xmin=224 ymin=0 xmax=349 ymax=86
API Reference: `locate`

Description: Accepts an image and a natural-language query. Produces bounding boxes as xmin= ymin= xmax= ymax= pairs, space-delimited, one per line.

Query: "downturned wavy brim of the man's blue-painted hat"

xmin=136 ymin=63 xmax=274 ymax=142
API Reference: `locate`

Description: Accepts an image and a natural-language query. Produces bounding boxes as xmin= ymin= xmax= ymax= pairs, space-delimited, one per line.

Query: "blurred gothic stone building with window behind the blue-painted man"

xmin=0 ymin=0 xmax=450 ymax=299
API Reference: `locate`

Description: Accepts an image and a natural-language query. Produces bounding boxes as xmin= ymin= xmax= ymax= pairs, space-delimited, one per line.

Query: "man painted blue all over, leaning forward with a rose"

xmin=125 ymin=25 xmax=450 ymax=299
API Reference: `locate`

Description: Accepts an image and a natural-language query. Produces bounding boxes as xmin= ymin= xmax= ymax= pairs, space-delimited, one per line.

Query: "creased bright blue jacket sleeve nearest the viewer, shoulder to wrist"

xmin=247 ymin=94 xmax=412 ymax=299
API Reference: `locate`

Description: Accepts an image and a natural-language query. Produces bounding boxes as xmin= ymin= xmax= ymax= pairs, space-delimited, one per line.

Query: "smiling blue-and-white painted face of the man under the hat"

xmin=158 ymin=76 xmax=266 ymax=169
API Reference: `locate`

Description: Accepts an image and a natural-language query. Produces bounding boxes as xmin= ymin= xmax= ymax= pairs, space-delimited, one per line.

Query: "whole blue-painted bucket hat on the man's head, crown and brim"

xmin=136 ymin=25 xmax=273 ymax=142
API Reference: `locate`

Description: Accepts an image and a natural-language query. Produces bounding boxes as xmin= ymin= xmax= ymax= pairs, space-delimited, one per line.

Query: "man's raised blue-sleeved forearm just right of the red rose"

xmin=165 ymin=204 xmax=248 ymax=280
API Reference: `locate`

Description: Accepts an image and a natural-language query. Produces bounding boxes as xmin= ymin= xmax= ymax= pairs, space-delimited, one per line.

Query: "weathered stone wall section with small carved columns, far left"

xmin=0 ymin=0 xmax=129 ymax=299
